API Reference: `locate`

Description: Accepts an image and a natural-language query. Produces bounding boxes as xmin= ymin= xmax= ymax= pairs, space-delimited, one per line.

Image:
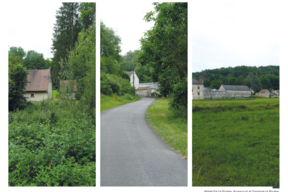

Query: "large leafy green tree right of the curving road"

xmin=138 ymin=3 xmax=187 ymax=112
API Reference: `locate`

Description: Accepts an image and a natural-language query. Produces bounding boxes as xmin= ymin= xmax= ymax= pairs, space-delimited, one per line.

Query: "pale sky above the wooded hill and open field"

xmin=189 ymin=0 xmax=279 ymax=72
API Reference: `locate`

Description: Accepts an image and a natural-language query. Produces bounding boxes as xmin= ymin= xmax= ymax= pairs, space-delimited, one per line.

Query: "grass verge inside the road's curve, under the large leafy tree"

xmin=146 ymin=98 xmax=187 ymax=159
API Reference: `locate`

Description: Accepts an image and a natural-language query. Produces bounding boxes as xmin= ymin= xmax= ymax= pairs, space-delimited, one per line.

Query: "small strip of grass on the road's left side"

xmin=100 ymin=94 xmax=141 ymax=112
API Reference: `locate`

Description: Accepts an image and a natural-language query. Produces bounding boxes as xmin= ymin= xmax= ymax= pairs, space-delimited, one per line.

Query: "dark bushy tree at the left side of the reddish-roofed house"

xmin=8 ymin=55 xmax=28 ymax=111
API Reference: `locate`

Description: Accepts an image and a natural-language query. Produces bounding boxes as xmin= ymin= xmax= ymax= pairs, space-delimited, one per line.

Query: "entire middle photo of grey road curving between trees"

xmin=99 ymin=1 xmax=188 ymax=186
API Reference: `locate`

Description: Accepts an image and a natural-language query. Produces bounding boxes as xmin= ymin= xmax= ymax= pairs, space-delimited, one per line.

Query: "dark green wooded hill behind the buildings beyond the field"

xmin=192 ymin=65 xmax=279 ymax=92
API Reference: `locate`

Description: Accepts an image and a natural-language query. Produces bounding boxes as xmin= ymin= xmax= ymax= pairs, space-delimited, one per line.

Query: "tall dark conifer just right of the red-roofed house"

xmin=51 ymin=3 xmax=81 ymax=88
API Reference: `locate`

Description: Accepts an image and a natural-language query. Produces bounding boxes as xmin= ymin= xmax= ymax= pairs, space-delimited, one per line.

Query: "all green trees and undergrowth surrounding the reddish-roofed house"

xmin=9 ymin=3 xmax=96 ymax=186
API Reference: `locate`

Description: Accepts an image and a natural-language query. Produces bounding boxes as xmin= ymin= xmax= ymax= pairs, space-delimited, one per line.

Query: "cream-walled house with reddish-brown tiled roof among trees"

xmin=24 ymin=69 xmax=52 ymax=101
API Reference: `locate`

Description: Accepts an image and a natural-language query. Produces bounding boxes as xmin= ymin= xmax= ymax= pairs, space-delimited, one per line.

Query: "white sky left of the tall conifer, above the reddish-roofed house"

xmin=7 ymin=1 xmax=62 ymax=59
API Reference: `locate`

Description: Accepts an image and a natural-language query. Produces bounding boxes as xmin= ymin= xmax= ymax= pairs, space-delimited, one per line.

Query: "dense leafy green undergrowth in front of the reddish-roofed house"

xmin=9 ymin=100 xmax=96 ymax=186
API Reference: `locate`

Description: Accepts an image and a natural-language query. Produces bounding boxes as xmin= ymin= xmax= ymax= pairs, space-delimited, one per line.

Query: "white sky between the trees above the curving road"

xmin=97 ymin=1 xmax=154 ymax=55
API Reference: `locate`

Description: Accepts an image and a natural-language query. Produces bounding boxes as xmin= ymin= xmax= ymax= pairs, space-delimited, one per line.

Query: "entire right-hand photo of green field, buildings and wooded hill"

xmin=189 ymin=1 xmax=280 ymax=188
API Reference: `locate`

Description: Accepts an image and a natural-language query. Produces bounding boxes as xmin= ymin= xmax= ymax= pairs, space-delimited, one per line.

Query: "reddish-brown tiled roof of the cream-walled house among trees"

xmin=26 ymin=69 xmax=50 ymax=91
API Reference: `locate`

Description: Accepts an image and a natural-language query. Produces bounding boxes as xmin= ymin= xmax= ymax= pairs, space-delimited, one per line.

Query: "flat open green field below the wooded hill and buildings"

xmin=192 ymin=98 xmax=279 ymax=186
